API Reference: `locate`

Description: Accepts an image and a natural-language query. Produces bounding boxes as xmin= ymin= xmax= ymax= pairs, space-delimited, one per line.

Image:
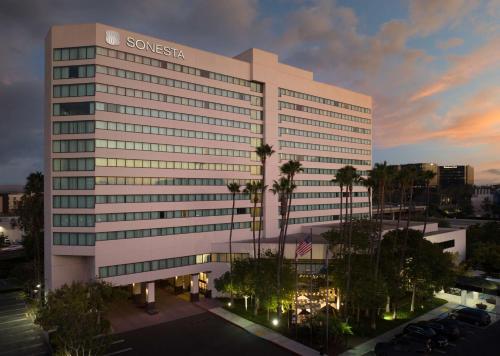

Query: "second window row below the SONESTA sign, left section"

xmin=96 ymin=65 xmax=262 ymax=106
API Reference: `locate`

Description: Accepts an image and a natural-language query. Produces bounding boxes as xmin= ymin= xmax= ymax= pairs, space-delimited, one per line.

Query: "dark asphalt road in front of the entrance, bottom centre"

xmin=107 ymin=312 xmax=293 ymax=356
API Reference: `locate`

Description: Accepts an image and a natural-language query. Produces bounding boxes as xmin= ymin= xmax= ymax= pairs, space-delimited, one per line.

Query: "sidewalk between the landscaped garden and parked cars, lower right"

xmin=341 ymin=303 xmax=458 ymax=356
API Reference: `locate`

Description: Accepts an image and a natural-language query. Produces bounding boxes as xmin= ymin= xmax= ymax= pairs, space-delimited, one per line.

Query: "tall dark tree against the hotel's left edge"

xmin=16 ymin=172 xmax=44 ymax=285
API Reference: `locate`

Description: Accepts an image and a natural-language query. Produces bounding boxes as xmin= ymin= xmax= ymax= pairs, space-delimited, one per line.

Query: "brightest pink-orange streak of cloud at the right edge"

xmin=410 ymin=37 xmax=500 ymax=101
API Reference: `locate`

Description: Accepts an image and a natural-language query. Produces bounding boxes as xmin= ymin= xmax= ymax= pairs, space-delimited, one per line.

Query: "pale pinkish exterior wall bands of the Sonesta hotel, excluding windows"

xmin=45 ymin=24 xmax=372 ymax=289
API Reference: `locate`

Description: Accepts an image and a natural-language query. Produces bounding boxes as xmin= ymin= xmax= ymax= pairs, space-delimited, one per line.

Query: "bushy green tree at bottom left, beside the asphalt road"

xmin=35 ymin=282 xmax=122 ymax=356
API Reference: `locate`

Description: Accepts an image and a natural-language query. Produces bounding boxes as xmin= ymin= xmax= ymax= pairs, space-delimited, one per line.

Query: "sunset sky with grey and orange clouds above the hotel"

xmin=0 ymin=0 xmax=500 ymax=184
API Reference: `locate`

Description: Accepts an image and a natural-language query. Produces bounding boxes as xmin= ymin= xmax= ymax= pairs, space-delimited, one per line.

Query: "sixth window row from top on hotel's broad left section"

xmin=95 ymin=139 xmax=254 ymax=161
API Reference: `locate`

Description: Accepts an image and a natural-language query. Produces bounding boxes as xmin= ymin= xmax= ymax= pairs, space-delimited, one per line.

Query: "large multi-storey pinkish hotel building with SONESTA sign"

xmin=45 ymin=24 xmax=372 ymax=302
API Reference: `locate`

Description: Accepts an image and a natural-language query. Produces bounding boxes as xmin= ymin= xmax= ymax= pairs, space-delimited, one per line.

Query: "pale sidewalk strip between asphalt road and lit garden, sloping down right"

xmin=208 ymin=307 xmax=319 ymax=355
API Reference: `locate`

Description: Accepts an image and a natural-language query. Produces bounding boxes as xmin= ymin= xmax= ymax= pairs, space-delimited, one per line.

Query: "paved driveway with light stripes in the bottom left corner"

xmin=0 ymin=292 xmax=49 ymax=356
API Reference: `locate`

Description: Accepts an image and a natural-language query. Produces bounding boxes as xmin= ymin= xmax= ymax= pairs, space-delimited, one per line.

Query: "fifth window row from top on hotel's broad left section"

xmin=96 ymin=121 xmax=261 ymax=147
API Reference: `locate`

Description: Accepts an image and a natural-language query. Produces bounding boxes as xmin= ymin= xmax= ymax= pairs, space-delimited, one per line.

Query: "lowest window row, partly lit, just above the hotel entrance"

xmin=99 ymin=253 xmax=248 ymax=278
